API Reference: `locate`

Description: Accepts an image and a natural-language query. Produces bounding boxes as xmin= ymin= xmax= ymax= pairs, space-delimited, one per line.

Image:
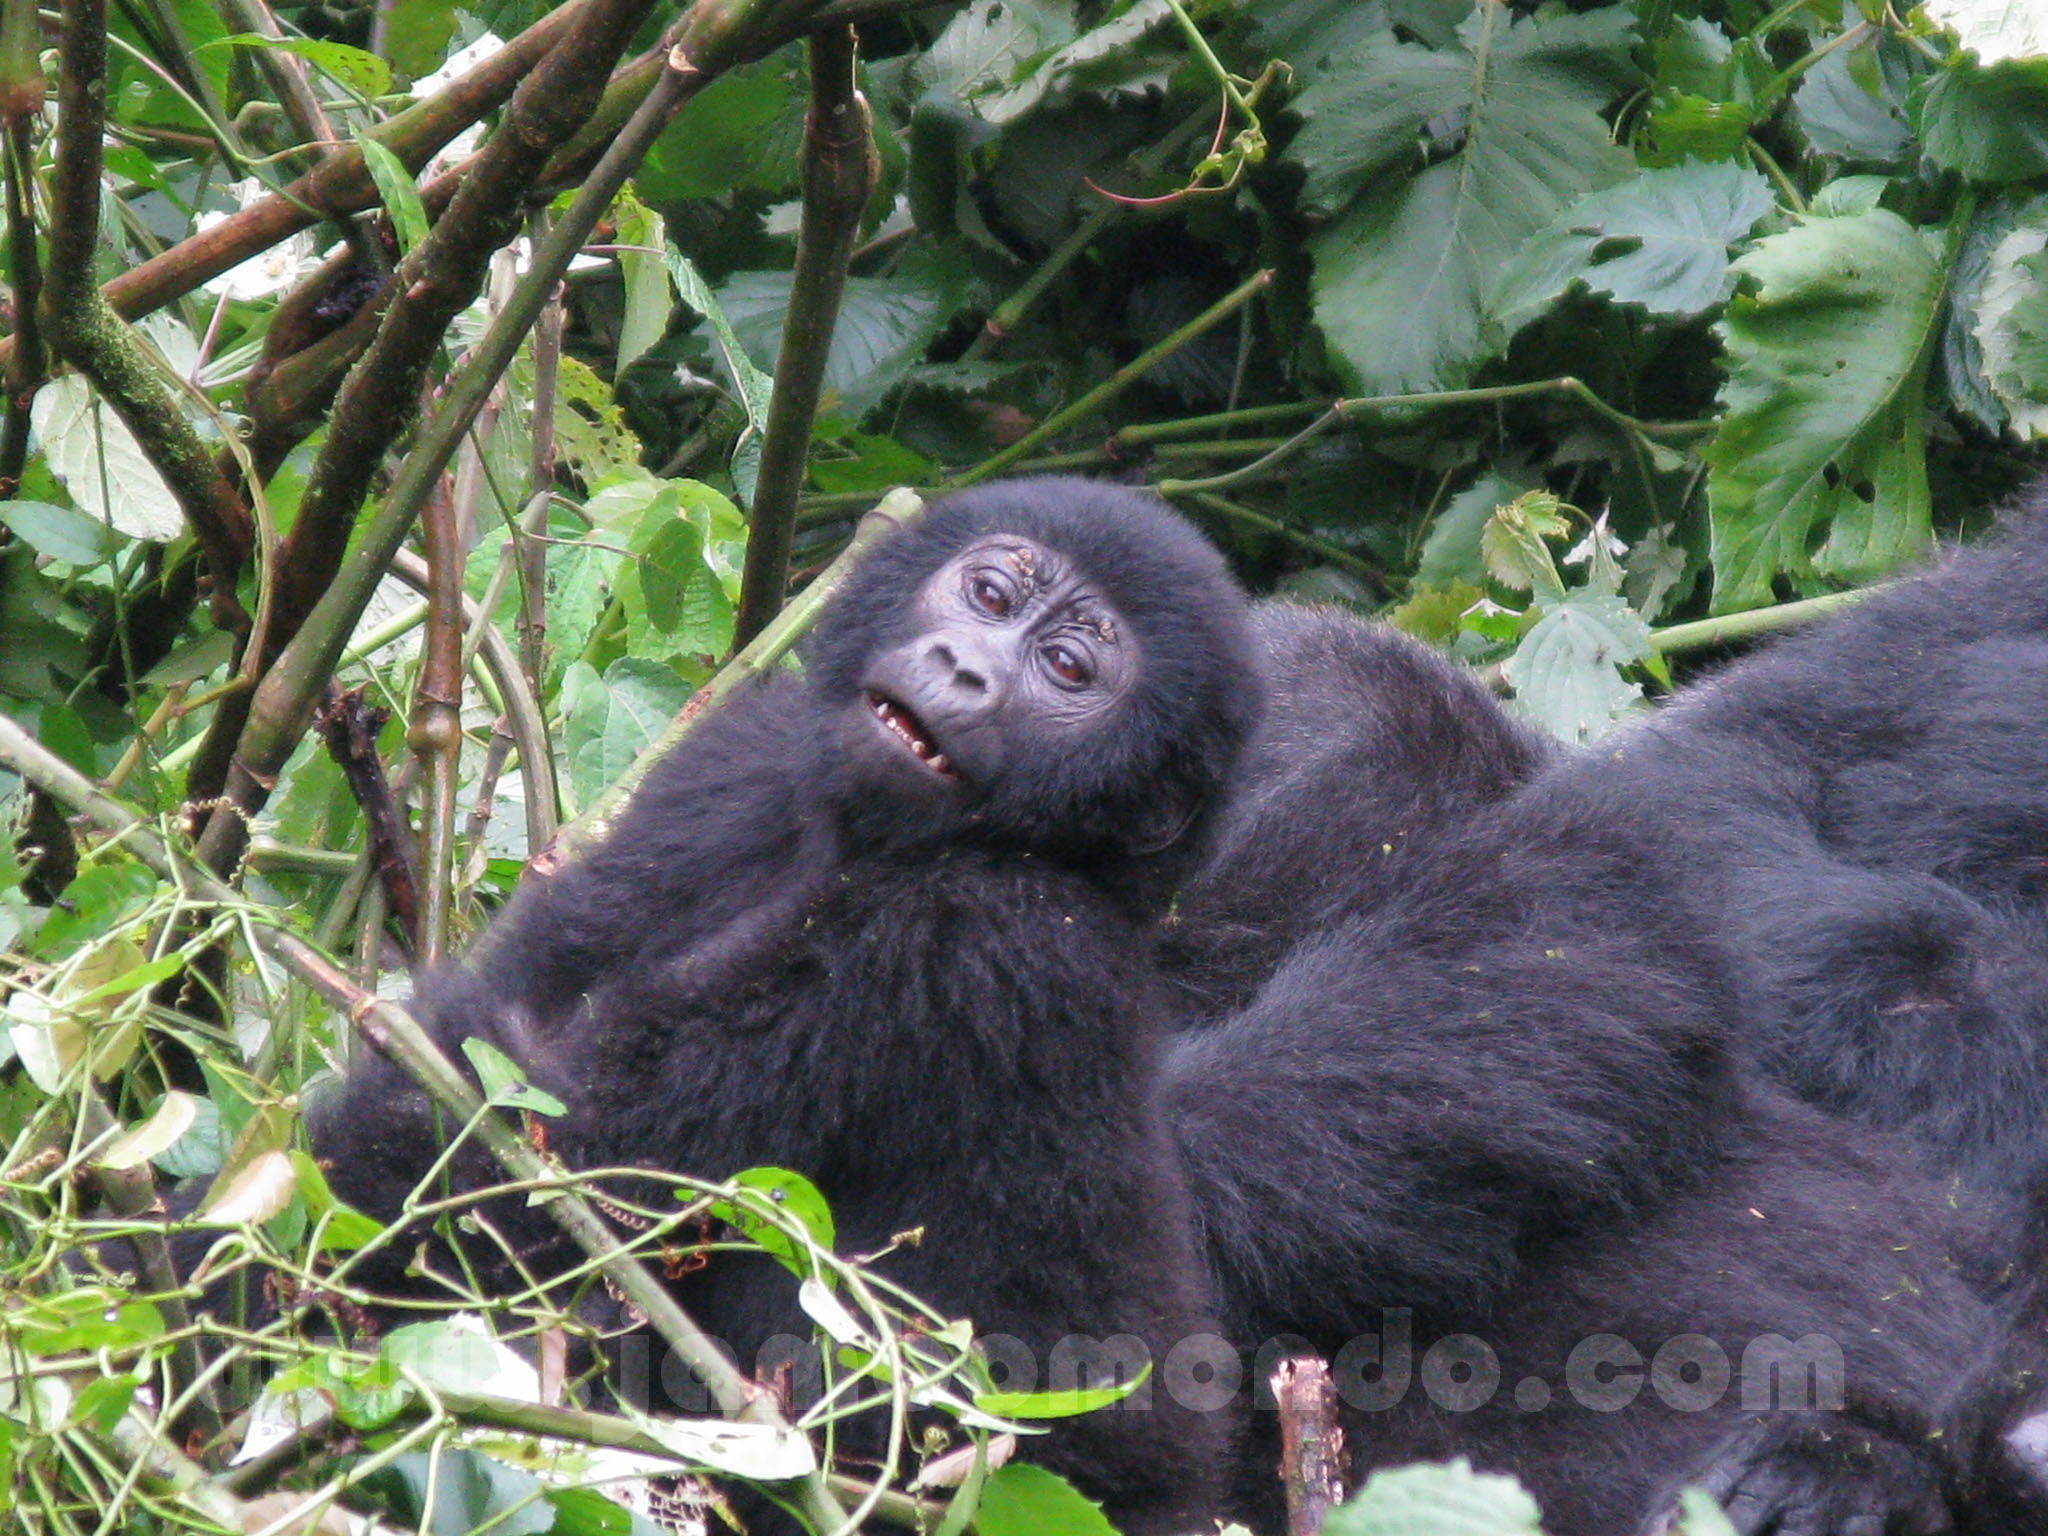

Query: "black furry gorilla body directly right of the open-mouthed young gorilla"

xmin=1163 ymin=606 xmax=2048 ymax=1536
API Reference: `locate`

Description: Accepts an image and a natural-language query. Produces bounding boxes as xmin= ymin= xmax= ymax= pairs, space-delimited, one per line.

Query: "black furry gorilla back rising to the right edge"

xmin=1556 ymin=499 xmax=2048 ymax=1192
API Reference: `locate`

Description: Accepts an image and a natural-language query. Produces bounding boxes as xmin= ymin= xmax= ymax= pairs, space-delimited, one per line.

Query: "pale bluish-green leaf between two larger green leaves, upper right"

xmin=1491 ymin=162 xmax=1776 ymax=332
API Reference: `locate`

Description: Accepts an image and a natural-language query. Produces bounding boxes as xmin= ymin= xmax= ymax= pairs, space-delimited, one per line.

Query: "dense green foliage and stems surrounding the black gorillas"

xmin=0 ymin=0 xmax=2048 ymax=1532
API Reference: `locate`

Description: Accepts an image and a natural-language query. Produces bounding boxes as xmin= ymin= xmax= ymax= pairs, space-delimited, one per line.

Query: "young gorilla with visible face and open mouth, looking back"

xmin=313 ymin=481 xmax=1255 ymax=1532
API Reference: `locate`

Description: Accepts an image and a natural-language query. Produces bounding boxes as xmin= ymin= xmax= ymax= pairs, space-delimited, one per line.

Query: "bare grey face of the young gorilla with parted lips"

xmin=856 ymin=535 xmax=1141 ymax=799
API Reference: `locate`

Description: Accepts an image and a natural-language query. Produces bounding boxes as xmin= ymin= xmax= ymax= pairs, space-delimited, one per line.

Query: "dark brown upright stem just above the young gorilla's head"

xmin=733 ymin=27 xmax=881 ymax=649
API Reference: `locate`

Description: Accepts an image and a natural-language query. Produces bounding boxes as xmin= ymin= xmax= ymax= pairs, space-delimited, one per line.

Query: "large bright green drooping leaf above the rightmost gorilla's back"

xmin=1704 ymin=209 xmax=1944 ymax=612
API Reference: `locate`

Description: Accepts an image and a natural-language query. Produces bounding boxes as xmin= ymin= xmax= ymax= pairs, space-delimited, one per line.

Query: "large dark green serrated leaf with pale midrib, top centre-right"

xmin=1288 ymin=6 xmax=1634 ymax=393
